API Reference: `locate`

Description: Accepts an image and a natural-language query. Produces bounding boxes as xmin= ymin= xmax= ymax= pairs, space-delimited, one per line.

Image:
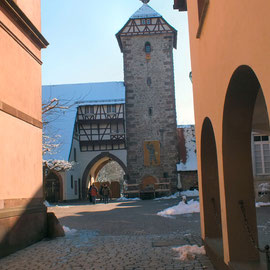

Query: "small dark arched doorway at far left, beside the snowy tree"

xmin=45 ymin=171 xmax=63 ymax=203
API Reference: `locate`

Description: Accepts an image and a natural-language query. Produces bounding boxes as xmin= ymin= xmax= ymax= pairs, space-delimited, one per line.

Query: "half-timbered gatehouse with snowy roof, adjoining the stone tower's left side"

xmin=43 ymin=82 xmax=126 ymax=200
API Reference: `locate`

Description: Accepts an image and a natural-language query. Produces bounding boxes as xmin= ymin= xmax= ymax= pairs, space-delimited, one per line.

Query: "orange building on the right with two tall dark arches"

xmin=174 ymin=0 xmax=270 ymax=270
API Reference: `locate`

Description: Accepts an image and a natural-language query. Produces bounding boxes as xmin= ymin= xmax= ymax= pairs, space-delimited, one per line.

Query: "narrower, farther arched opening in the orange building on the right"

xmin=201 ymin=118 xmax=223 ymax=243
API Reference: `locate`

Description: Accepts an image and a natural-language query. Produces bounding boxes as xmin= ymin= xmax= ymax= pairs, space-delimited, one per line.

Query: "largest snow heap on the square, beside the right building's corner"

xmin=157 ymin=200 xmax=200 ymax=218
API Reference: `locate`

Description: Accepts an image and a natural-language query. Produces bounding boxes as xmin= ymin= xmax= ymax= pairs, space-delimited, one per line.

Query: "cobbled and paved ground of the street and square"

xmin=0 ymin=197 xmax=270 ymax=270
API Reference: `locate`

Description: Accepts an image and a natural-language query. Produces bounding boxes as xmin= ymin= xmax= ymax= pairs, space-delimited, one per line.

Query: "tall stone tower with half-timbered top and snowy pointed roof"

xmin=116 ymin=3 xmax=177 ymax=190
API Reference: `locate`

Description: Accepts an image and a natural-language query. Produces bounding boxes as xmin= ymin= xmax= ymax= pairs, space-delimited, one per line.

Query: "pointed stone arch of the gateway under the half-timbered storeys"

xmin=82 ymin=152 xmax=127 ymax=199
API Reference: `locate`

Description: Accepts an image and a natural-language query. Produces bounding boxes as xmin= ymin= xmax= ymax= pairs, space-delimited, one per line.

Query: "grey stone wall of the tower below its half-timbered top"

xmin=122 ymin=34 xmax=177 ymax=189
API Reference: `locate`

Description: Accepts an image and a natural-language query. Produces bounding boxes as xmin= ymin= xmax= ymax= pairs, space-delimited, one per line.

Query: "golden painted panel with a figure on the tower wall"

xmin=144 ymin=141 xmax=160 ymax=167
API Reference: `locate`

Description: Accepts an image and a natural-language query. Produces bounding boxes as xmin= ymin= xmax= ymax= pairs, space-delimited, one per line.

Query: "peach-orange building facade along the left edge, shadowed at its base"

xmin=0 ymin=0 xmax=48 ymax=257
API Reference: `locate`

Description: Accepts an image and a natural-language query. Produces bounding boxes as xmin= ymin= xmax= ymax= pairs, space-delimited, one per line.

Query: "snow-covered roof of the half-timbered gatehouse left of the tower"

xmin=42 ymin=82 xmax=125 ymax=160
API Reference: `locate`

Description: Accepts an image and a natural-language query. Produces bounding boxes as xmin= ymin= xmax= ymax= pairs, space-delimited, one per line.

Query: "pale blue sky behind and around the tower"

xmin=41 ymin=0 xmax=194 ymax=124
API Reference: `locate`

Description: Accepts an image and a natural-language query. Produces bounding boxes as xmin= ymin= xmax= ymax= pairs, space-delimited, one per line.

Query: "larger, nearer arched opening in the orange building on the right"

xmin=222 ymin=66 xmax=269 ymax=262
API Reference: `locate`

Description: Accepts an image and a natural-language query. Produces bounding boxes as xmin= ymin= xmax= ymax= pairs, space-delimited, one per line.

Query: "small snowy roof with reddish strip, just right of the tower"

xmin=177 ymin=125 xmax=198 ymax=171
